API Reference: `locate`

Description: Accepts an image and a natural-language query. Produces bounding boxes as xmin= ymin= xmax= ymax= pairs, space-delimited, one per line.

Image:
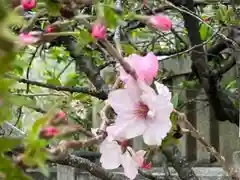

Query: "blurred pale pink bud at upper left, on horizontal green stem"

xmin=19 ymin=31 xmax=42 ymax=45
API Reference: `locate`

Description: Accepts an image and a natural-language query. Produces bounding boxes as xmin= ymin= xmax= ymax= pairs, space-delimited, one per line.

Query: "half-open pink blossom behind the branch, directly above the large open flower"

xmin=120 ymin=52 xmax=159 ymax=85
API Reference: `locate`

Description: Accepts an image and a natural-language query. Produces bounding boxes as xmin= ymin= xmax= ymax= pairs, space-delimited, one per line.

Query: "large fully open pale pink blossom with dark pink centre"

xmin=107 ymin=80 xmax=173 ymax=145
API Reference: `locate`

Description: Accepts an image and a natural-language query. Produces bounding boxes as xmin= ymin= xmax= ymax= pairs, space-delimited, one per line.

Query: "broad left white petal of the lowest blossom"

xmin=99 ymin=140 xmax=122 ymax=169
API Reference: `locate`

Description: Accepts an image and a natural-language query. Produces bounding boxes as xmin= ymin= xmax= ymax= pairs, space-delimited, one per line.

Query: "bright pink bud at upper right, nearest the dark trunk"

xmin=149 ymin=15 xmax=172 ymax=31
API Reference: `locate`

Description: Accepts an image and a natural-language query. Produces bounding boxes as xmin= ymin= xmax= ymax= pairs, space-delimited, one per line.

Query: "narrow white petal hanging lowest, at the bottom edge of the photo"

xmin=121 ymin=151 xmax=139 ymax=180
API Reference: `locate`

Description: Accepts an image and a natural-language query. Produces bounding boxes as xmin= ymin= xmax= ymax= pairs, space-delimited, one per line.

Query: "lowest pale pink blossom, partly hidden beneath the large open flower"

xmin=100 ymin=139 xmax=146 ymax=179
